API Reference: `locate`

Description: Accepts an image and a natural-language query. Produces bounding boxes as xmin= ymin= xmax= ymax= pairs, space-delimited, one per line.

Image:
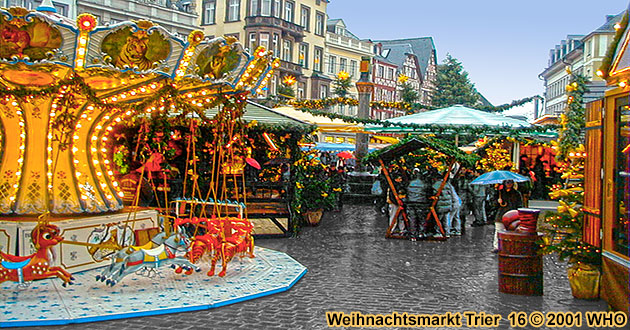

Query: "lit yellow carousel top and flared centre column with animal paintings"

xmin=0 ymin=7 xmax=279 ymax=214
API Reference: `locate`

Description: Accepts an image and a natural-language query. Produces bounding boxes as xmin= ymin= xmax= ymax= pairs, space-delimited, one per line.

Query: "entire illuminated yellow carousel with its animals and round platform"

xmin=0 ymin=1 xmax=306 ymax=327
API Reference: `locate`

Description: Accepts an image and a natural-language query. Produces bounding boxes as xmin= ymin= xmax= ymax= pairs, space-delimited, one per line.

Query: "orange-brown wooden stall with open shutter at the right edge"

xmin=584 ymin=10 xmax=630 ymax=313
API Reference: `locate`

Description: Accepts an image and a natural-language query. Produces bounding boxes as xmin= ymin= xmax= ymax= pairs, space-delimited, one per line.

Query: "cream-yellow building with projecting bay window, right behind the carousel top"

xmin=197 ymin=0 xmax=330 ymax=98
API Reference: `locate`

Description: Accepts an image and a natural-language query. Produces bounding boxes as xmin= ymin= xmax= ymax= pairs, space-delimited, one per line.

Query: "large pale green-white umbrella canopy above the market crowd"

xmin=366 ymin=105 xmax=531 ymax=131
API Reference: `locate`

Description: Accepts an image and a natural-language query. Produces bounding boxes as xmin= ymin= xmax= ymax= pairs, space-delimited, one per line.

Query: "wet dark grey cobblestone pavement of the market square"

xmin=17 ymin=205 xmax=607 ymax=330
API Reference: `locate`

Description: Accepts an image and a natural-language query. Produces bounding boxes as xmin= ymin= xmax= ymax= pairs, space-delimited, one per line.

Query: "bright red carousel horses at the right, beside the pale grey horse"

xmin=189 ymin=218 xmax=254 ymax=277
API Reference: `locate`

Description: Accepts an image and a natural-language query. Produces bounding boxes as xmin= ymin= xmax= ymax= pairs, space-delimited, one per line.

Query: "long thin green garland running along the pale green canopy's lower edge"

xmin=288 ymin=107 xmax=558 ymax=136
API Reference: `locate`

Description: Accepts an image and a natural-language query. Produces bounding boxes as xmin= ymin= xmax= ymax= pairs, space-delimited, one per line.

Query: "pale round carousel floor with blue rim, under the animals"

xmin=0 ymin=247 xmax=306 ymax=327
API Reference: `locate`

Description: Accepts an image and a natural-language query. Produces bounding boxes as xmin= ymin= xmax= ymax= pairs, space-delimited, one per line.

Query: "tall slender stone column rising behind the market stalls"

xmin=355 ymin=56 xmax=374 ymax=171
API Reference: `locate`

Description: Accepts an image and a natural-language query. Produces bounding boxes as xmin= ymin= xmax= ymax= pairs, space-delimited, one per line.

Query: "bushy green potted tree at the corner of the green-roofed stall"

xmin=292 ymin=153 xmax=341 ymax=226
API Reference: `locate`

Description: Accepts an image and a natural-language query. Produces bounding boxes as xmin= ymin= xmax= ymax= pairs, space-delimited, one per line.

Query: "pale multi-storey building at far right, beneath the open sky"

xmin=538 ymin=13 xmax=623 ymax=118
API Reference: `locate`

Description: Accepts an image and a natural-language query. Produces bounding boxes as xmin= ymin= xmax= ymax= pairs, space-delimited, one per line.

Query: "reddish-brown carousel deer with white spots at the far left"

xmin=0 ymin=223 xmax=74 ymax=286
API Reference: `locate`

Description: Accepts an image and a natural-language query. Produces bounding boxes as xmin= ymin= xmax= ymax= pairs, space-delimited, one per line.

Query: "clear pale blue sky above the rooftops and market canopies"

xmin=328 ymin=0 xmax=629 ymax=105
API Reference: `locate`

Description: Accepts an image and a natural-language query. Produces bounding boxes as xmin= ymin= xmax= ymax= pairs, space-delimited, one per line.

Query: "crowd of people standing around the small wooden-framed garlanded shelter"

xmin=375 ymin=168 xmax=532 ymax=252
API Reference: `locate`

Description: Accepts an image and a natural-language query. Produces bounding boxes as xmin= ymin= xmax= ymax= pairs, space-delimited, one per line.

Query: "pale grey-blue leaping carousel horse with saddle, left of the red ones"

xmin=100 ymin=232 xmax=201 ymax=286
